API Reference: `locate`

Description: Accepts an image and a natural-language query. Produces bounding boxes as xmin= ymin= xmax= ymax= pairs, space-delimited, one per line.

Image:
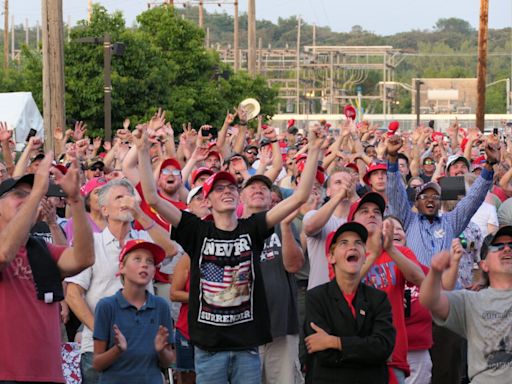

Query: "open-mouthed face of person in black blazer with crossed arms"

xmin=328 ymin=231 xmax=366 ymax=276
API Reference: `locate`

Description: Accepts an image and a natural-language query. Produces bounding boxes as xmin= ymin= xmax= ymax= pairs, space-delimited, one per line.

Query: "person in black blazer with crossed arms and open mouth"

xmin=306 ymin=222 xmax=395 ymax=384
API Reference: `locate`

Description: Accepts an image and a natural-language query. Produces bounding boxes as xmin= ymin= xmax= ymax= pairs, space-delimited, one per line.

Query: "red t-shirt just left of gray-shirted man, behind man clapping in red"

xmin=405 ymin=264 xmax=433 ymax=351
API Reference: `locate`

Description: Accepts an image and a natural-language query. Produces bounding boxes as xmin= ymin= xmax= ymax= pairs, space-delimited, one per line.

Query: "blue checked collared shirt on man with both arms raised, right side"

xmin=386 ymin=163 xmax=494 ymax=266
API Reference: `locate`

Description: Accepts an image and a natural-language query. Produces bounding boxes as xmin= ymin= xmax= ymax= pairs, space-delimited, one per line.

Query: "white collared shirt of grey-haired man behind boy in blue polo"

xmin=65 ymin=226 xmax=153 ymax=353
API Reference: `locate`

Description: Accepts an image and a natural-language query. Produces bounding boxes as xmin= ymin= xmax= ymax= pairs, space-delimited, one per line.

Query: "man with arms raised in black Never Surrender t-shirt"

xmin=134 ymin=124 xmax=325 ymax=384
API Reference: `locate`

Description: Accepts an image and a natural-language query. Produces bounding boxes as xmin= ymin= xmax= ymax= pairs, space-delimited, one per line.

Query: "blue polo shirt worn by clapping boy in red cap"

xmin=93 ymin=290 xmax=172 ymax=384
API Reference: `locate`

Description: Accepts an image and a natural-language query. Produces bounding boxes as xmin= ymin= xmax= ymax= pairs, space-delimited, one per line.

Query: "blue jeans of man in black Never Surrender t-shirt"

xmin=194 ymin=347 xmax=261 ymax=384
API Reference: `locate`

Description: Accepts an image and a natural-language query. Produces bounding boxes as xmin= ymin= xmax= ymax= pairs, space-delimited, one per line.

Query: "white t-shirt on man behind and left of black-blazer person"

xmin=303 ymin=210 xmax=347 ymax=290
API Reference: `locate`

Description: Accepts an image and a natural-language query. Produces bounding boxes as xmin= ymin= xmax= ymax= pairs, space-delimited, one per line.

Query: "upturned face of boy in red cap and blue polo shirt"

xmin=119 ymin=248 xmax=156 ymax=287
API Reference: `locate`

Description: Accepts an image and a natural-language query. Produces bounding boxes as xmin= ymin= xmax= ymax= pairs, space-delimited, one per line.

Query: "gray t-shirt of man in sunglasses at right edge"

xmin=434 ymin=288 xmax=512 ymax=384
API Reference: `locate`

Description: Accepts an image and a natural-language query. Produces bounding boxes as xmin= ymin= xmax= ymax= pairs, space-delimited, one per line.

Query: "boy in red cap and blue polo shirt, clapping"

xmin=93 ymin=240 xmax=173 ymax=384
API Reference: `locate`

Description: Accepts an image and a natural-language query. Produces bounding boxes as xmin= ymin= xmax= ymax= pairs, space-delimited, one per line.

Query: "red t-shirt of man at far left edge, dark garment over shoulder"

xmin=0 ymin=244 xmax=66 ymax=383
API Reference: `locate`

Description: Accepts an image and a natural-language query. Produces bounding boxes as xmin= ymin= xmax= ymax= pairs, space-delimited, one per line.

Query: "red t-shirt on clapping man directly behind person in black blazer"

xmin=364 ymin=246 xmax=419 ymax=376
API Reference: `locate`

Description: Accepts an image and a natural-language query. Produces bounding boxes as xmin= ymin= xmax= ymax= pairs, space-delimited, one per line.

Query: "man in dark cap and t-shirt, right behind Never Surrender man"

xmin=240 ymin=175 xmax=304 ymax=384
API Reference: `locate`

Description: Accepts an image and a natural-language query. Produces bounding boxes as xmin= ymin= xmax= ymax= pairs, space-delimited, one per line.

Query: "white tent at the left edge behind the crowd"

xmin=0 ymin=92 xmax=44 ymax=144
